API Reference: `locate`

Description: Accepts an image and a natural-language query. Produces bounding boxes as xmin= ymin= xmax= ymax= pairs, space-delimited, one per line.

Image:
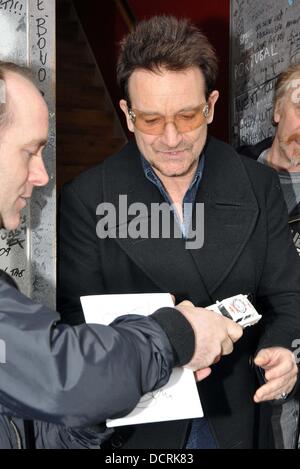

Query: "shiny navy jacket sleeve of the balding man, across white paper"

xmin=0 ymin=282 xmax=195 ymax=427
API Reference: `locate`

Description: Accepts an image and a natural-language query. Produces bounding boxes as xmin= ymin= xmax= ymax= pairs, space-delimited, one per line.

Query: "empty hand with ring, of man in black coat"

xmin=254 ymin=347 xmax=298 ymax=402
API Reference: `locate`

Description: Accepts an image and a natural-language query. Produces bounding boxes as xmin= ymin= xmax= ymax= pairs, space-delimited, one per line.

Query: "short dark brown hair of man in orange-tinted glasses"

xmin=117 ymin=15 xmax=218 ymax=101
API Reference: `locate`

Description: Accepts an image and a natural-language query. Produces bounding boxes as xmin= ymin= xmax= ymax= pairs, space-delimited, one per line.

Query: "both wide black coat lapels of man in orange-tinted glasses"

xmin=103 ymin=135 xmax=258 ymax=305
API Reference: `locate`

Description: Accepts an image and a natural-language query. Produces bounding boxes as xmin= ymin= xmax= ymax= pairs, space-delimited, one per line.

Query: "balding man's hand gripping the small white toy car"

xmin=176 ymin=301 xmax=243 ymax=372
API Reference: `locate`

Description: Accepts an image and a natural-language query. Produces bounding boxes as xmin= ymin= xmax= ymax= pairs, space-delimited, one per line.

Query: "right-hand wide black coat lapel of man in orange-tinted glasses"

xmin=190 ymin=138 xmax=259 ymax=295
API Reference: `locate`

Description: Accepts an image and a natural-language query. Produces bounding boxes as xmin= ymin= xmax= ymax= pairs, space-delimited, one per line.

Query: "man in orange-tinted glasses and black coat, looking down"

xmin=60 ymin=16 xmax=300 ymax=449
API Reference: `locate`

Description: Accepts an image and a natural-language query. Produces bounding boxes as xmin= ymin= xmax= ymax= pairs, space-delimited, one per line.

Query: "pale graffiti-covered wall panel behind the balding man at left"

xmin=0 ymin=0 xmax=56 ymax=307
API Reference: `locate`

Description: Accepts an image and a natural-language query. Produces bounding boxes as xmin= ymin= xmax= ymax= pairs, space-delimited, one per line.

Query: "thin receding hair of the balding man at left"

xmin=0 ymin=60 xmax=34 ymax=130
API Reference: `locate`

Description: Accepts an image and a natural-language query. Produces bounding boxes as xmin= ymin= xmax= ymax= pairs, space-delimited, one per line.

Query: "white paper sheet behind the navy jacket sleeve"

xmin=80 ymin=293 xmax=203 ymax=427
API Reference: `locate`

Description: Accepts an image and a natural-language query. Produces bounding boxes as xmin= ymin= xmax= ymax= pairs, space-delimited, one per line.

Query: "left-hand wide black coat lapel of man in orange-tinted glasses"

xmin=103 ymin=144 xmax=209 ymax=303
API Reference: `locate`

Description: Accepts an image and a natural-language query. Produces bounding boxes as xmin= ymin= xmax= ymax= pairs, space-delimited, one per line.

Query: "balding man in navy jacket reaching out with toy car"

xmin=0 ymin=61 xmax=242 ymax=449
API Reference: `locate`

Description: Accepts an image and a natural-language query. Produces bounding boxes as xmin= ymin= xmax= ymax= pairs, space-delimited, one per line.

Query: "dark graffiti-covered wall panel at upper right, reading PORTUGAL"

xmin=230 ymin=0 xmax=300 ymax=146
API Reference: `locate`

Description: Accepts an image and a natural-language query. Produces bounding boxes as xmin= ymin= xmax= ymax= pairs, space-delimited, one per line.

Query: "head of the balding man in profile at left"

xmin=0 ymin=63 xmax=49 ymax=230
